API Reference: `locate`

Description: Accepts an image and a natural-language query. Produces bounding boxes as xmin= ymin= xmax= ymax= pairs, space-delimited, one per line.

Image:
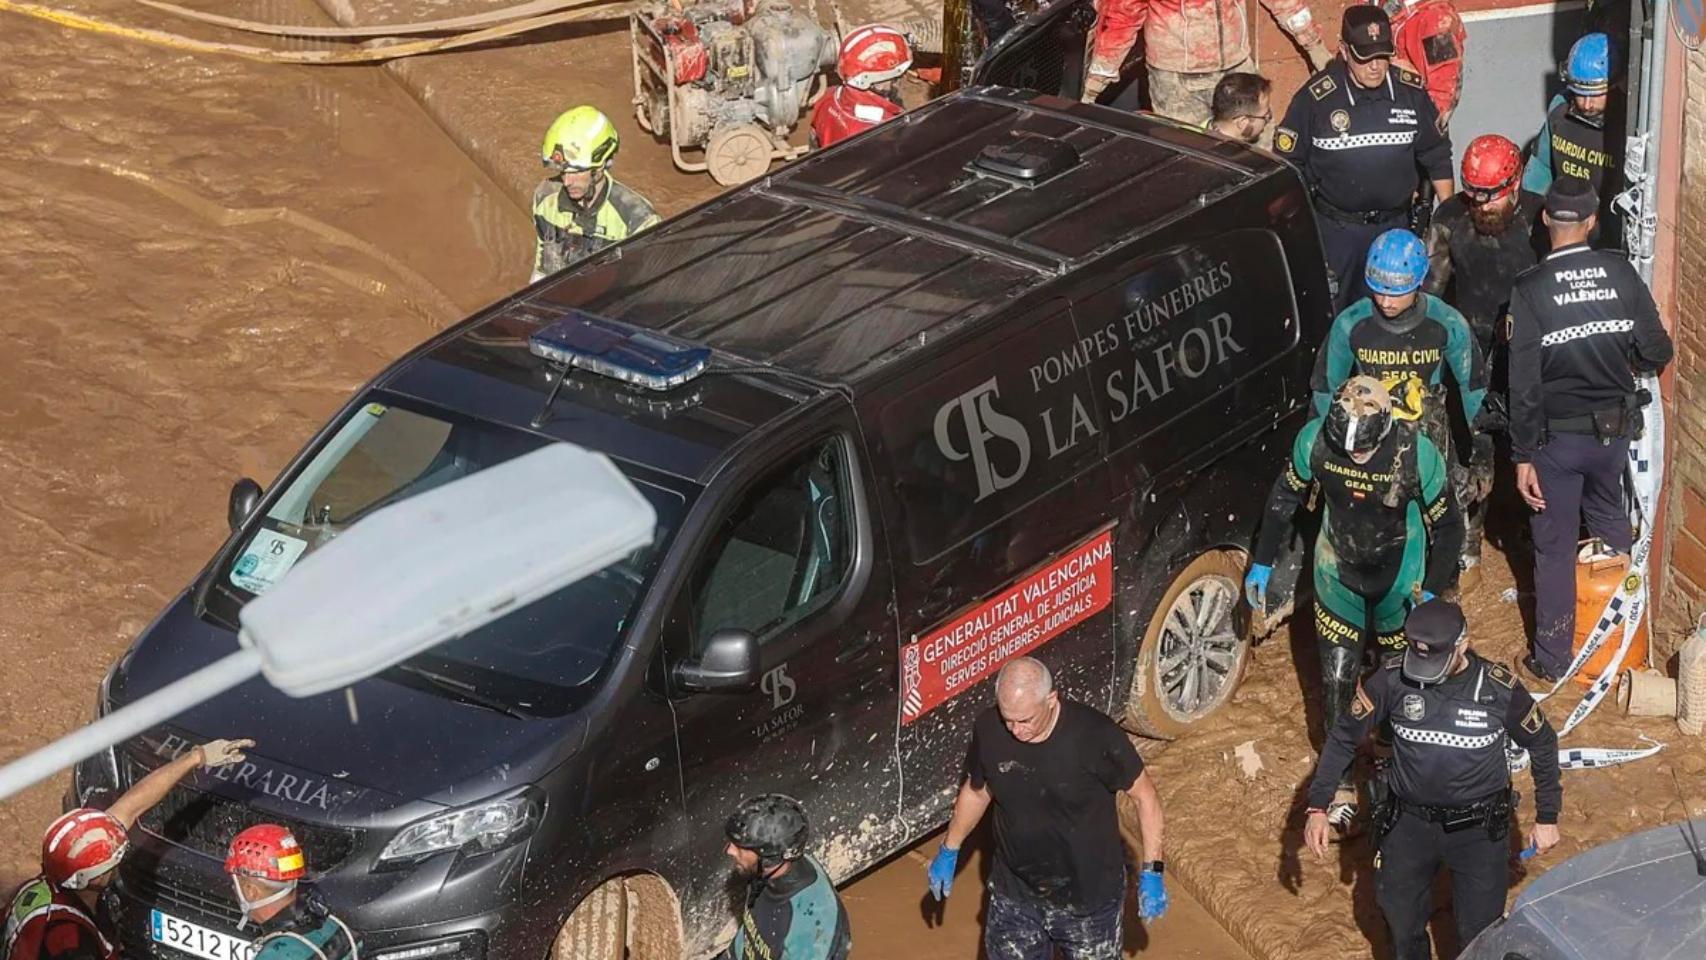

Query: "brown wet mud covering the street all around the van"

xmin=0 ymin=0 xmax=1706 ymax=960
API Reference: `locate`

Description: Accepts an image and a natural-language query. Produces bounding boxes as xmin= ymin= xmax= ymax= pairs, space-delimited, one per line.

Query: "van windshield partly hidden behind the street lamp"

xmin=208 ymin=397 xmax=684 ymax=716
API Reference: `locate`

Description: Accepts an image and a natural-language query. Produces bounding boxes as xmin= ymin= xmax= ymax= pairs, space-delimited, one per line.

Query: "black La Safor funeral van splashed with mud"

xmin=73 ymin=87 xmax=1331 ymax=960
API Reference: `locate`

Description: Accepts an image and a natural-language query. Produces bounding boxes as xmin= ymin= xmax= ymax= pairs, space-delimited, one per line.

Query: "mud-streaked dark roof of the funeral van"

xmin=397 ymin=87 xmax=1285 ymax=476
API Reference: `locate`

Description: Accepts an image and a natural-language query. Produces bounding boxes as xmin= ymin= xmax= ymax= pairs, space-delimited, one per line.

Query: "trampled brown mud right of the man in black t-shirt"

xmin=1138 ymin=518 xmax=1706 ymax=960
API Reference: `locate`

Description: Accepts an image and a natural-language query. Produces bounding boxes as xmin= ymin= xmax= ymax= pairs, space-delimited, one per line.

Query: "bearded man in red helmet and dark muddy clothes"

xmin=1423 ymin=133 xmax=1542 ymax=592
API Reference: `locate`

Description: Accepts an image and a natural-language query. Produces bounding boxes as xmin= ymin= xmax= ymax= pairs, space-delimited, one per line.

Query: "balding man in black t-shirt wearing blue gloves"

xmin=930 ymin=656 xmax=1167 ymax=960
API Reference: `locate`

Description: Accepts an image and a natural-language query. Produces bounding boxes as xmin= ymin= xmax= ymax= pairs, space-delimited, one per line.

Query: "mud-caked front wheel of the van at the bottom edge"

xmin=548 ymin=873 xmax=681 ymax=960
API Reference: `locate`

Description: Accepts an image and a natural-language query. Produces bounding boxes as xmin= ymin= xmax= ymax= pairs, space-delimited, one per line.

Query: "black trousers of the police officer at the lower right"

xmin=1375 ymin=812 xmax=1510 ymax=960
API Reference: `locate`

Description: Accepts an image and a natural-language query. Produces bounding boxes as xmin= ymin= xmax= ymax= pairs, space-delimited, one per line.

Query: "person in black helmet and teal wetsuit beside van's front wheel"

xmin=722 ymin=793 xmax=853 ymax=960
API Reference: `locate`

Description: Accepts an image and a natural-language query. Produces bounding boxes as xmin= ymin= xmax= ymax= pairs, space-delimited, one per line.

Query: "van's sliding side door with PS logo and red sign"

xmin=875 ymin=300 xmax=1114 ymax=827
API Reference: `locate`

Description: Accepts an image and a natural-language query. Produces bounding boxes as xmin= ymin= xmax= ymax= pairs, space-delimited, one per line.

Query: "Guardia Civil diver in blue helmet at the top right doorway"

xmin=1522 ymin=34 xmax=1624 ymax=238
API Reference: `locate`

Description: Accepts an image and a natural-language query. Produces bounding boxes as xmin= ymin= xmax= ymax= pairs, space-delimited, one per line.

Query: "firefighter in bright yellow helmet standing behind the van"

xmin=532 ymin=106 xmax=659 ymax=281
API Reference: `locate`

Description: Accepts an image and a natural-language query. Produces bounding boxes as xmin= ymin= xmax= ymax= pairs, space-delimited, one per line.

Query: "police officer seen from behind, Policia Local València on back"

xmin=1505 ymin=179 xmax=1675 ymax=682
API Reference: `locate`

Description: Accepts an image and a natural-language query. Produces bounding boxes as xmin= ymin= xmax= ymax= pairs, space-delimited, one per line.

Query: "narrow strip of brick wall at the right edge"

xmin=1653 ymin=44 xmax=1706 ymax=663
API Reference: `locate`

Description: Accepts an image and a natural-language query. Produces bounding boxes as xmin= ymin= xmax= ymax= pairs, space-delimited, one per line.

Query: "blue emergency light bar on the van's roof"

xmin=527 ymin=310 xmax=711 ymax=390
